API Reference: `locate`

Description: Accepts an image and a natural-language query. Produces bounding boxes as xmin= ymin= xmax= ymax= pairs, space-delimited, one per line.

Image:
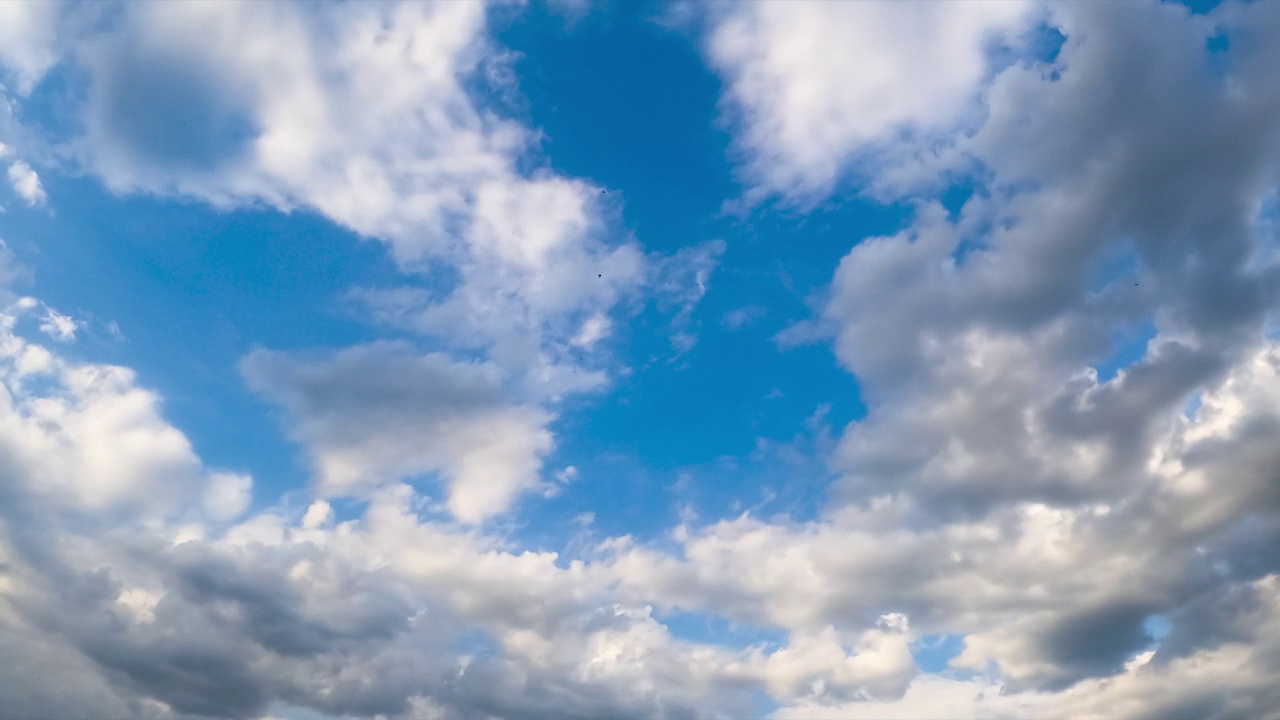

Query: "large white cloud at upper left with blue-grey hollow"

xmin=2 ymin=3 xmax=646 ymax=395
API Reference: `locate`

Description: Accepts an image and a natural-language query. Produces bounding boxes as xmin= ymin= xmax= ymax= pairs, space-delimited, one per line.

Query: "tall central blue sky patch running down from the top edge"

xmin=499 ymin=4 xmax=910 ymax=539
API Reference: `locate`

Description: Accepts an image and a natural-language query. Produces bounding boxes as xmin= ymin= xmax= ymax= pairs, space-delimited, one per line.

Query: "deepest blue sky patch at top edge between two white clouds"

xmin=498 ymin=3 xmax=741 ymax=252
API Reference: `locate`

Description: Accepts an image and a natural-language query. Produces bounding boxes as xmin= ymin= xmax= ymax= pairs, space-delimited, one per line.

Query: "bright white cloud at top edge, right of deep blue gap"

xmin=707 ymin=0 xmax=1033 ymax=200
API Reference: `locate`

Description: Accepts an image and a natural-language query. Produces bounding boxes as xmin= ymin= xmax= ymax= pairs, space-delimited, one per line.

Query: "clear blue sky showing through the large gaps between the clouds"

xmin=6 ymin=0 xmax=908 ymax=538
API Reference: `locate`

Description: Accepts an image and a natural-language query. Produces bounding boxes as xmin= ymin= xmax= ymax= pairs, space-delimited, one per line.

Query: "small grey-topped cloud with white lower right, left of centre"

xmin=243 ymin=343 xmax=552 ymax=523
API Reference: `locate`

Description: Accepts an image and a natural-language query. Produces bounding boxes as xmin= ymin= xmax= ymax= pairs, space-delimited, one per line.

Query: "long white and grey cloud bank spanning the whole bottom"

xmin=0 ymin=279 xmax=1280 ymax=717
